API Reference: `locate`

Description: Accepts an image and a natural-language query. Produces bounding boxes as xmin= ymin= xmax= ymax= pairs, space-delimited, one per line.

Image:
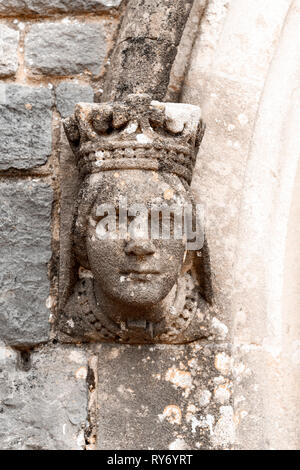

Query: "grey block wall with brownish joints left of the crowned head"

xmin=0 ymin=0 xmax=122 ymax=449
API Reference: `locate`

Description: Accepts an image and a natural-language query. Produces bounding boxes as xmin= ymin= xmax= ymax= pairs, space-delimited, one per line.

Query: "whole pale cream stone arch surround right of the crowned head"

xmin=182 ymin=0 xmax=300 ymax=449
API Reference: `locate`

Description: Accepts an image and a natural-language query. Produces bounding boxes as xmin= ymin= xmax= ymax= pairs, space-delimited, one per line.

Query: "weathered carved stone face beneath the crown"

xmin=86 ymin=170 xmax=190 ymax=316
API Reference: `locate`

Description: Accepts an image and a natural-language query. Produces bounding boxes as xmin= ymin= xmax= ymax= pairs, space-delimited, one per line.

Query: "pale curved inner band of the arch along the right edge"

xmin=233 ymin=0 xmax=300 ymax=449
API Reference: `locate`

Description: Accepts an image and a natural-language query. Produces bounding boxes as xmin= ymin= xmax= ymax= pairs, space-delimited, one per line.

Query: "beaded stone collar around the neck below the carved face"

xmin=60 ymin=274 xmax=203 ymax=344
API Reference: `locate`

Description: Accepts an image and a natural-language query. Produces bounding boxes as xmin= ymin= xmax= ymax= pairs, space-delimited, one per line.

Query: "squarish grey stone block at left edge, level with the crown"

xmin=0 ymin=84 xmax=52 ymax=169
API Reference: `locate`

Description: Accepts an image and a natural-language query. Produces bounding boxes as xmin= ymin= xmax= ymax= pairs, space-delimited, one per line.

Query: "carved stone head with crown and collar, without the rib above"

xmin=61 ymin=95 xmax=209 ymax=343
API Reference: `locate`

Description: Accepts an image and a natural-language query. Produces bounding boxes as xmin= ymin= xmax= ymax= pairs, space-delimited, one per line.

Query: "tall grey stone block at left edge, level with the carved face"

xmin=0 ymin=180 xmax=52 ymax=346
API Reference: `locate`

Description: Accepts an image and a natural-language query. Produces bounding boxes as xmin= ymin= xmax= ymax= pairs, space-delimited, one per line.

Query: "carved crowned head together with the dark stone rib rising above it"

xmin=58 ymin=0 xmax=210 ymax=344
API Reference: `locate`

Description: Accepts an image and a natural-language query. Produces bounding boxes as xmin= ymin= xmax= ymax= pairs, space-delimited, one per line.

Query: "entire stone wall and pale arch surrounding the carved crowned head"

xmin=0 ymin=0 xmax=300 ymax=450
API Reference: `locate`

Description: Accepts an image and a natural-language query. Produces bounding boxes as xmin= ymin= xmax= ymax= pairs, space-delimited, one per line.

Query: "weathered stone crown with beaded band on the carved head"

xmin=64 ymin=94 xmax=205 ymax=184
